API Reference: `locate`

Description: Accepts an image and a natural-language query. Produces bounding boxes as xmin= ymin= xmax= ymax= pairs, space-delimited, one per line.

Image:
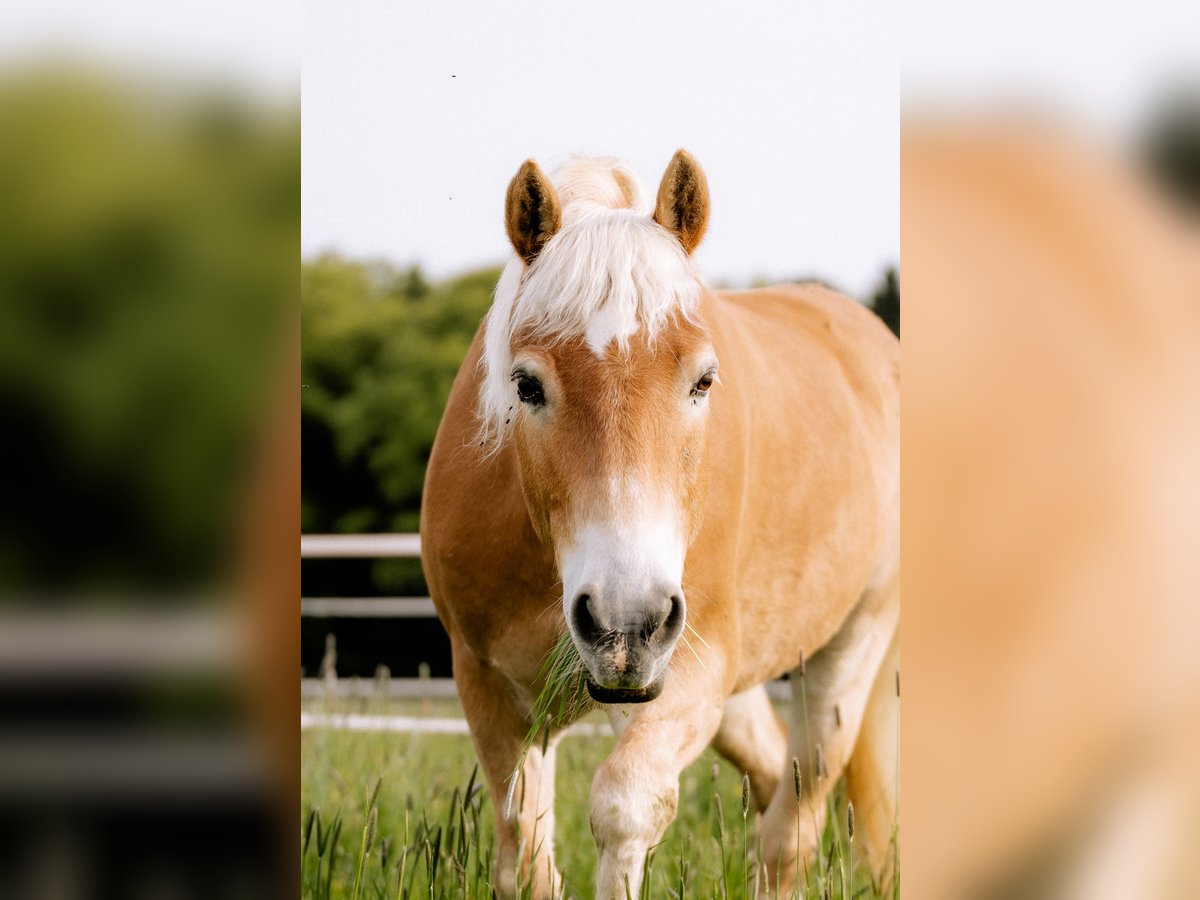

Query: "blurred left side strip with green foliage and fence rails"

xmin=0 ymin=0 xmax=300 ymax=898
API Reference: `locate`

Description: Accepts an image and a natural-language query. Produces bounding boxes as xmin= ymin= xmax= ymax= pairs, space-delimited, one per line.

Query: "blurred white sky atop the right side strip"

xmin=898 ymin=0 xmax=1200 ymax=144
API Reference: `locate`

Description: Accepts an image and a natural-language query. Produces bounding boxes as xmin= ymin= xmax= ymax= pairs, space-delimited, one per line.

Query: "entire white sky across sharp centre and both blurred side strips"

xmin=0 ymin=0 xmax=1200 ymax=296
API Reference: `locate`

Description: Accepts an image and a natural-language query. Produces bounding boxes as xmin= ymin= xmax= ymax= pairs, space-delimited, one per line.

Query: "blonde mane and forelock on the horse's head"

xmin=480 ymin=156 xmax=701 ymax=449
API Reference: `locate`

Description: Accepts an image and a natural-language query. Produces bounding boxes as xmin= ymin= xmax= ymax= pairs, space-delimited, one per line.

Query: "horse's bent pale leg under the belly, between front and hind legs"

xmin=713 ymin=684 xmax=788 ymax=810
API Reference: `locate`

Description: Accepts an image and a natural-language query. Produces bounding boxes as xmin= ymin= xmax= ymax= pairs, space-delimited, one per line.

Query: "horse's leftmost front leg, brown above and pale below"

xmin=452 ymin=641 xmax=562 ymax=900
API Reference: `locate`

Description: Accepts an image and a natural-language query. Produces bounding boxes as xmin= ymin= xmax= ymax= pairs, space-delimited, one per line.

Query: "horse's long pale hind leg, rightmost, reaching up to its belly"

xmin=763 ymin=586 xmax=899 ymax=892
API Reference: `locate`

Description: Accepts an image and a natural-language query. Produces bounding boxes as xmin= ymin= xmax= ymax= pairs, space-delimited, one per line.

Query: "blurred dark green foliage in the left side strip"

xmin=0 ymin=67 xmax=300 ymax=594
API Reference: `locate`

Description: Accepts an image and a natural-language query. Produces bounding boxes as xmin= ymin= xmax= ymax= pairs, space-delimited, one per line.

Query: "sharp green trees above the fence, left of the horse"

xmin=301 ymin=254 xmax=499 ymax=556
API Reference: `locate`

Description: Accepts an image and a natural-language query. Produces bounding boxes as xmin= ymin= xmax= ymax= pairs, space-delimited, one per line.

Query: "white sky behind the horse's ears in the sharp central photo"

xmin=301 ymin=0 xmax=900 ymax=298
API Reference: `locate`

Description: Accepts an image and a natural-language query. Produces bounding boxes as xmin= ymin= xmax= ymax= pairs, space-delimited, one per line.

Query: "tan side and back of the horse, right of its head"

xmin=689 ymin=284 xmax=900 ymax=685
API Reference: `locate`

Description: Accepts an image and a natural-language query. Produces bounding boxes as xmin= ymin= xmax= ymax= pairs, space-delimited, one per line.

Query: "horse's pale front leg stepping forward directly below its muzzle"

xmin=590 ymin=666 xmax=725 ymax=900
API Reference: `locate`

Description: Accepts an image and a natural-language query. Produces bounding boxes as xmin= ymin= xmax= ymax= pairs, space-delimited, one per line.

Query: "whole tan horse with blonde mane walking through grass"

xmin=421 ymin=150 xmax=899 ymax=898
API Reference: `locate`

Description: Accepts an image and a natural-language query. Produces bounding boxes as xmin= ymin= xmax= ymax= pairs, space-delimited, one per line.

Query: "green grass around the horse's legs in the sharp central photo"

xmin=300 ymin=701 xmax=898 ymax=900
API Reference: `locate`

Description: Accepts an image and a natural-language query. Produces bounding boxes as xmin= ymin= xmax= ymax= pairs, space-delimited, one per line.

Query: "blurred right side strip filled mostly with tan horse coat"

xmin=900 ymin=2 xmax=1200 ymax=900
